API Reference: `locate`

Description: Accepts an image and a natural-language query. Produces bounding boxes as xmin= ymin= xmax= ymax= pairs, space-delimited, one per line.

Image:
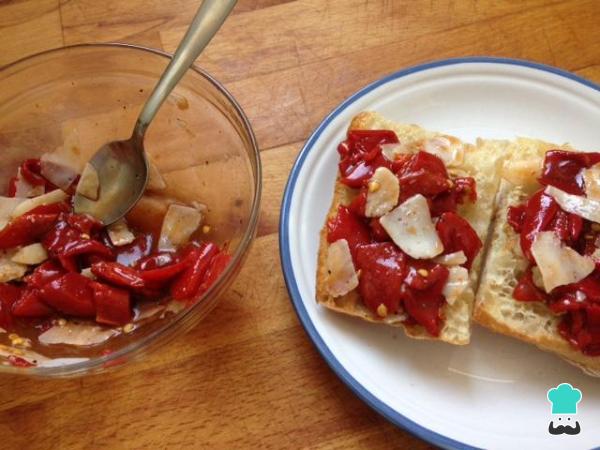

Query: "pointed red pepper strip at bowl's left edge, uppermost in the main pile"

xmin=0 ymin=213 xmax=58 ymax=250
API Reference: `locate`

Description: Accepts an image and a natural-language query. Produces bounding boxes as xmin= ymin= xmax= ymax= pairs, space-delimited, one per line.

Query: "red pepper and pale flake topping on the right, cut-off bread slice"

xmin=508 ymin=150 xmax=600 ymax=356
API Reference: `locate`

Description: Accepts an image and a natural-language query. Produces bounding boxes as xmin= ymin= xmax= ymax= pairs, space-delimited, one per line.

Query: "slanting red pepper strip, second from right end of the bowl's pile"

xmin=171 ymin=243 xmax=219 ymax=300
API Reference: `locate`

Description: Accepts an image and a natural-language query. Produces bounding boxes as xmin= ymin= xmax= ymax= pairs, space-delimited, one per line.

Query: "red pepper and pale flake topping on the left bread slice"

xmin=327 ymin=130 xmax=482 ymax=336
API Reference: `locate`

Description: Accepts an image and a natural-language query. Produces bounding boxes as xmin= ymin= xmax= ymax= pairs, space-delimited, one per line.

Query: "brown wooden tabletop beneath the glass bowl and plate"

xmin=0 ymin=0 xmax=600 ymax=449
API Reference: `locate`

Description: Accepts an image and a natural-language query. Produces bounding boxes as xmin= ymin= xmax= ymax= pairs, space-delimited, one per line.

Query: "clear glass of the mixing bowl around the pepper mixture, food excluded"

xmin=0 ymin=44 xmax=261 ymax=376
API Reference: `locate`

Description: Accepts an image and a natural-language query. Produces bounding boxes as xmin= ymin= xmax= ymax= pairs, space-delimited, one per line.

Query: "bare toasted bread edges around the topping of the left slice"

xmin=316 ymin=112 xmax=508 ymax=345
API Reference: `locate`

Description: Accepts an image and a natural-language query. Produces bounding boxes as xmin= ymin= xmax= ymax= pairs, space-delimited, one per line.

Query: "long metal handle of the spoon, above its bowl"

xmin=133 ymin=0 xmax=237 ymax=142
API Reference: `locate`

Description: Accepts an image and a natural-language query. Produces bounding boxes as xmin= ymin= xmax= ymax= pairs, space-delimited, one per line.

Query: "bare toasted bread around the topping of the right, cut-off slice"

xmin=473 ymin=138 xmax=600 ymax=376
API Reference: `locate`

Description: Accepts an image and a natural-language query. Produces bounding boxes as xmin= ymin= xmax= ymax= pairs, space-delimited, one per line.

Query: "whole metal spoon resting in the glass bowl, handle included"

xmin=74 ymin=0 xmax=237 ymax=225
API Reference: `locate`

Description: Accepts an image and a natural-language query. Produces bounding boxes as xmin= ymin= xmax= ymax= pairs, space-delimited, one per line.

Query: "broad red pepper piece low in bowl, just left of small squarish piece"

xmin=40 ymin=273 xmax=96 ymax=317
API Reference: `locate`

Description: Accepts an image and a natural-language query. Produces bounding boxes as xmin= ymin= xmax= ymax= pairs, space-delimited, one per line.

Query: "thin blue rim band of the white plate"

xmin=279 ymin=56 xmax=600 ymax=450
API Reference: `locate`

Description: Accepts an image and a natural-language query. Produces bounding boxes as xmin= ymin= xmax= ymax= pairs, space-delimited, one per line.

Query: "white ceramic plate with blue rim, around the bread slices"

xmin=280 ymin=58 xmax=600 ymax=449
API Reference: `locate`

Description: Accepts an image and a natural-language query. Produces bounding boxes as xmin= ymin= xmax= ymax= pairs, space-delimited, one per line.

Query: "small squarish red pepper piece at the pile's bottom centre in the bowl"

xmin=90 ymin=282 xmax=132 ymax=326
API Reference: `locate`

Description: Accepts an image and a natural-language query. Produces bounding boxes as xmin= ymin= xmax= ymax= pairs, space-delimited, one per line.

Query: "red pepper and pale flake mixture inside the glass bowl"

xmin=0 ymin=154 xmax=237 ymax=367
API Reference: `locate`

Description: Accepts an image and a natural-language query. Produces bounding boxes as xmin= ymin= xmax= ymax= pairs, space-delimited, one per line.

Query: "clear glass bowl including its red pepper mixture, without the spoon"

xmin=0 ymin=45 xmax=261 ymax=376
